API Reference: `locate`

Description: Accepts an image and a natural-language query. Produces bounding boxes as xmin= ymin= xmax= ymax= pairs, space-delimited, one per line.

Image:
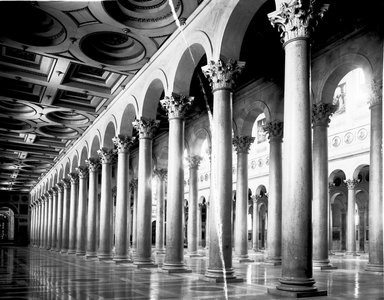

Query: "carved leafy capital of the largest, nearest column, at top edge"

xmin=268 ymin=0 xmax=329 ymax=45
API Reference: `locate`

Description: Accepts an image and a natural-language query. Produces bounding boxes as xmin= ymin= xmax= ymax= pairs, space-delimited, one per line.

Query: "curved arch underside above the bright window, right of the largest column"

xmin=312 ymin=53 xmax=373 ymax=103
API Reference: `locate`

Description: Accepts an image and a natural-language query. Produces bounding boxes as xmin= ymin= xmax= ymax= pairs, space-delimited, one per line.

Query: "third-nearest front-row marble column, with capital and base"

xmin=160 ymin=94 xmax=196 ymax=272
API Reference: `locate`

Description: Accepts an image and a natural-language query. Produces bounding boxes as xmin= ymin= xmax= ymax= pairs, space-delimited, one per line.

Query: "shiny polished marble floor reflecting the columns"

xmin=0 ymin=245 xmax=384 ymax=300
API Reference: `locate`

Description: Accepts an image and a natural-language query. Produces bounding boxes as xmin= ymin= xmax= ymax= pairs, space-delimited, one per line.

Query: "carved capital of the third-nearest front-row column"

xmin=160 ymin=93 xmax=194 ymax=120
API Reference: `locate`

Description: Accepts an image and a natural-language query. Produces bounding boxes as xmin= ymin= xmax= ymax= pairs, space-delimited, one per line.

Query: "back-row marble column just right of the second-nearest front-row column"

xmin=232 ymin=136 xmax=255 ymax=262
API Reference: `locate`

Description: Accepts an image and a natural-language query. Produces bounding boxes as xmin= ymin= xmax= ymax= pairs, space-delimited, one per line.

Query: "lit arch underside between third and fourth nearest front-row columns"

xmin=140 ymin=69 xmax=168 ymax=119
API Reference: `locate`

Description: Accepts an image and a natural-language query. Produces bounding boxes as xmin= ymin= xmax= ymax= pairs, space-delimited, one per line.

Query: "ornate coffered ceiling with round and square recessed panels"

xmin=0 ymin=0 xmax=201 ymax=191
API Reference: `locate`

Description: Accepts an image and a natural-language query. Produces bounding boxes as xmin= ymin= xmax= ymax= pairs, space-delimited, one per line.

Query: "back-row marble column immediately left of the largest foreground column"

xmin=264 ymin=121 xmax=283 ymax=266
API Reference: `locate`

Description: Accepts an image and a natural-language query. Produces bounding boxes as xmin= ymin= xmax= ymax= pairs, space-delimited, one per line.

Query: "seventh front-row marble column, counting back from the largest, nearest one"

xmin=85 ymin=157 xmax=100 ymax=259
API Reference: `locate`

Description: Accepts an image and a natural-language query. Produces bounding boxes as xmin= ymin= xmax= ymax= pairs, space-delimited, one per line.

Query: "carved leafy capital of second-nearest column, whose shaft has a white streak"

xmin=201 ymin=59 xmax=245 ymax=92
